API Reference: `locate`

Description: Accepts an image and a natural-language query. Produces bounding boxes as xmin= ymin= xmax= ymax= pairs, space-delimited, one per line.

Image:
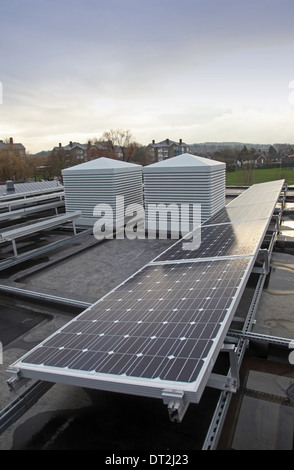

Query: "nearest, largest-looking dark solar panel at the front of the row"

xmin=16 ymin=258 xmax=251 ymax=383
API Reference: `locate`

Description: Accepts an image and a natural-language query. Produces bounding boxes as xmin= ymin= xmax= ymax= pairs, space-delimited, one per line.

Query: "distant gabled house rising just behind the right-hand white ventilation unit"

xmin=146 ymin=139 xmax=189 ymax=163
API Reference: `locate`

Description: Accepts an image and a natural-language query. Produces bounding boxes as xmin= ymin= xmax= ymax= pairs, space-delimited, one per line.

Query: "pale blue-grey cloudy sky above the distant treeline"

xmin=0 ymin=0 xmax=294 ymax=153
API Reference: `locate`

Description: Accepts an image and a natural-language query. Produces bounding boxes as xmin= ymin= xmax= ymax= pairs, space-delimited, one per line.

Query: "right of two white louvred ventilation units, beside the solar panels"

xmin=143 ymin=153 xmax=226 ymax=230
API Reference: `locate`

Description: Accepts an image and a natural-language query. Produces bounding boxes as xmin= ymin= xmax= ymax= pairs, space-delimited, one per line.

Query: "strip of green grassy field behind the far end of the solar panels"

xmin=226 ymin=168 xmax=294 ymax=186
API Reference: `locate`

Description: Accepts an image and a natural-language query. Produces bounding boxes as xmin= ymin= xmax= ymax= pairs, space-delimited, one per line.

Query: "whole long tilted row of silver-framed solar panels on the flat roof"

xmin=8 ymin=181 xmax=284 ymax=412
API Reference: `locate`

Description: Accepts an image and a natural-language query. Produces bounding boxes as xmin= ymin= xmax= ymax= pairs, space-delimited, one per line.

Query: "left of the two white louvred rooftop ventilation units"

xmin=62 ymin=157 xmax=143 ymax=226
